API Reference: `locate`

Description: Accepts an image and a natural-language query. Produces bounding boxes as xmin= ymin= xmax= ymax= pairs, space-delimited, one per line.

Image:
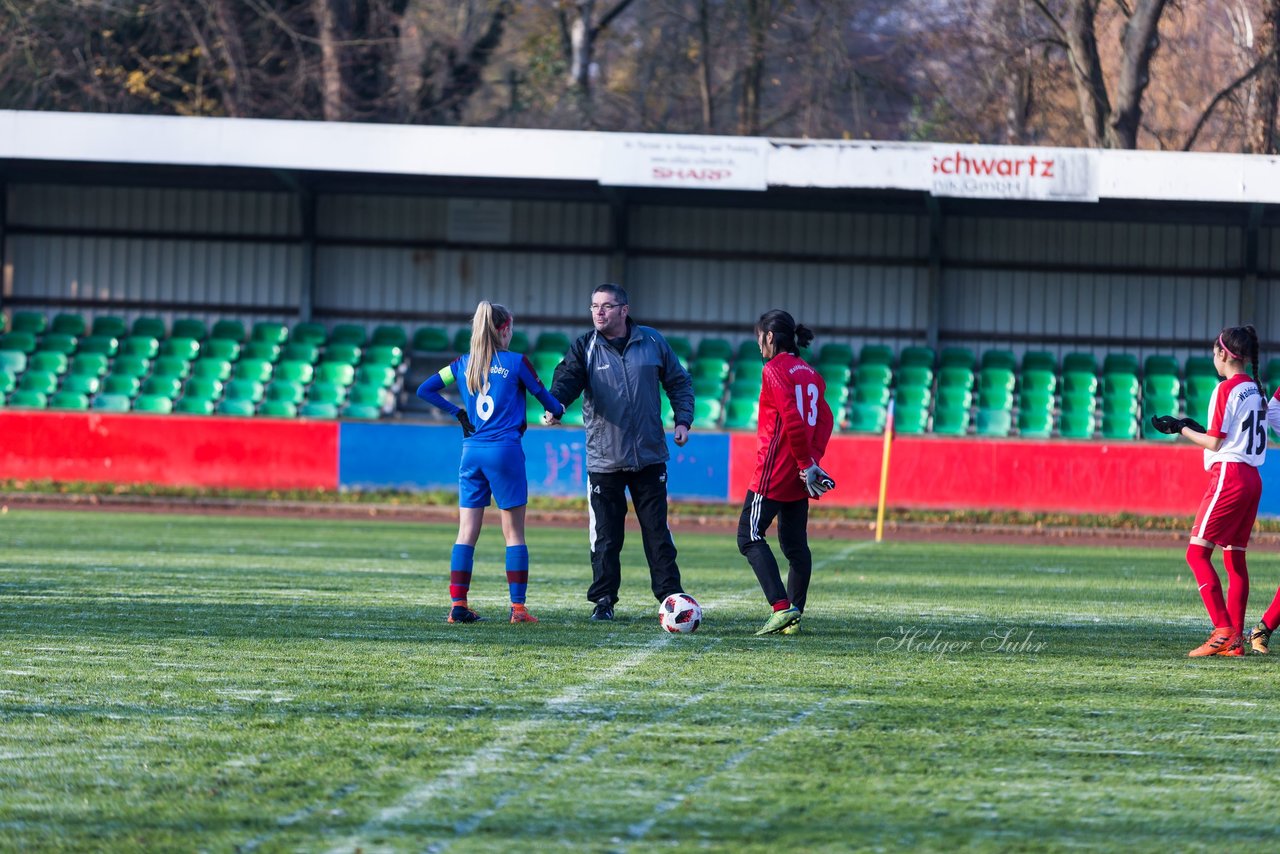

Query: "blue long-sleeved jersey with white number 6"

xmin=419 ymin=350 xmax=564 ymax=444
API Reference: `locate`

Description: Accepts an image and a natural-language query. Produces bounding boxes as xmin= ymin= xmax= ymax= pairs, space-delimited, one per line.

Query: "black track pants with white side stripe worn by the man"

xmin=586 ymin=462 xmax=684 ymax=602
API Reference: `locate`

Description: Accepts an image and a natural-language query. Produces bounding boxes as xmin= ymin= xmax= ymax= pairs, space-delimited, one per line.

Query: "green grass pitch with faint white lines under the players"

xmin=0 ymin=511 xmax=1280 ymax=851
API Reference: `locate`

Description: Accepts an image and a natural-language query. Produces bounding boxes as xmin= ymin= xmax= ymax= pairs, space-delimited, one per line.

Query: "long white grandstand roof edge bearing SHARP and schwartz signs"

xmin=0 ymin=110 xmax=1280 ymax=204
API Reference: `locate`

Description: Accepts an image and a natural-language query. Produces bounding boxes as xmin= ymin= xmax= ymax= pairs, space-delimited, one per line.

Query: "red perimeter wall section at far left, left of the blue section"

xmin=0 ymin=412 xmax=338 ymax=489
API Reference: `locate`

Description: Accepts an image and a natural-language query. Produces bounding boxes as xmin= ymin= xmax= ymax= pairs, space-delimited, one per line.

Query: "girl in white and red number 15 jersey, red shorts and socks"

xmin=1152 ymin=326 xmax=1267 ymax=657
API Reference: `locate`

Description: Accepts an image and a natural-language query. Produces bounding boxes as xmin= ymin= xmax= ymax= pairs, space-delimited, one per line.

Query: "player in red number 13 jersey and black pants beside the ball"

xmin=737 ymin=309 xmax=836 ymax=635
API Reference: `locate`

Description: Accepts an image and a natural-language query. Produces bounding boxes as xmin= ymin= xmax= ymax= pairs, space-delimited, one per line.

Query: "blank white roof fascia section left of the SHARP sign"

xmin=0 ymin=110 xmax=600 ymax=182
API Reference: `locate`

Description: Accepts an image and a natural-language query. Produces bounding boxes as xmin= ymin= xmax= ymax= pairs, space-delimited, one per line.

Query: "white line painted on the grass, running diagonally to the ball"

xmin=329 ymin=594 xmax=745 ymax=854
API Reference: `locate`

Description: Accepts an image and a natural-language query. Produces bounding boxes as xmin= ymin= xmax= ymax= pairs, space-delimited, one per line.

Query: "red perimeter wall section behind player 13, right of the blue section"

xmin=730 ymin=434 xmax=1207 ymax=515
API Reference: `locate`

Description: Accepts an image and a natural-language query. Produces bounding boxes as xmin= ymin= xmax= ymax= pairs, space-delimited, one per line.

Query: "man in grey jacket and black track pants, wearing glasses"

xmin=544 ymin=284 xmax=694 ymax=620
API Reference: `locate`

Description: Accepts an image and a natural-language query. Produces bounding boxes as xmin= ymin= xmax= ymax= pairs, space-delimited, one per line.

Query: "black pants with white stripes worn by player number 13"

xmin=737 ymin=489 xmax=813 ymax=611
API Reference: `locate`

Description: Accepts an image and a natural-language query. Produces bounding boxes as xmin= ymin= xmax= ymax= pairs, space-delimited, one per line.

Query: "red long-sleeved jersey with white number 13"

xmin=751 ymin=353 xmax=835 ymax=501
